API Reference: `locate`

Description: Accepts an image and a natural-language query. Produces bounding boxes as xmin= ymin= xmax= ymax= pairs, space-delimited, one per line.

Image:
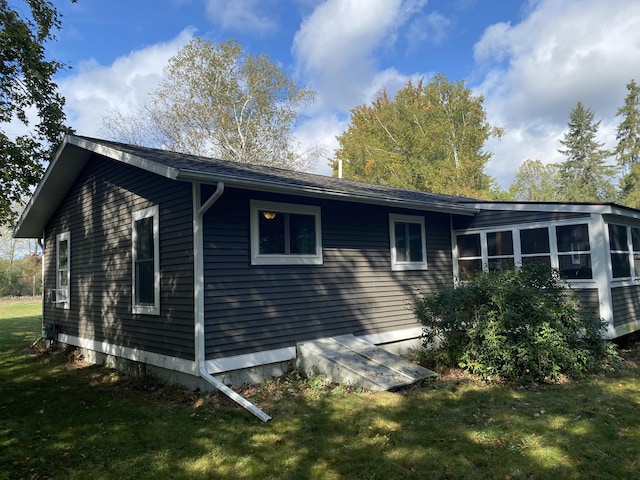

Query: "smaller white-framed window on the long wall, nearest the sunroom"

xmin=389 ymin=213 xmax=427 ymax=270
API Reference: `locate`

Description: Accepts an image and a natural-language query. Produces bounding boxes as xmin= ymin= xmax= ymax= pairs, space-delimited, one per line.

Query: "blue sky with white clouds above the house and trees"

xmin=11 ymin=0 xmax=640 ymax=189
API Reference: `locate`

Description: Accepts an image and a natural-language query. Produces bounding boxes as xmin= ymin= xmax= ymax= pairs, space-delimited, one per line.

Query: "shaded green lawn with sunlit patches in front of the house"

xmin=0 ymin=303 xmax=640 ymax=480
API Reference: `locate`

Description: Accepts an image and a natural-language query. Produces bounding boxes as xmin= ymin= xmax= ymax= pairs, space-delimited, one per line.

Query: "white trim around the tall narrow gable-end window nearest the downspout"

xmin=131 ymin=205 xmax=160 ymax=315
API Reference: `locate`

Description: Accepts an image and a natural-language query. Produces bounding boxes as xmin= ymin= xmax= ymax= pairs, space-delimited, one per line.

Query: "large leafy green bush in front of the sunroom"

xmin=416 ymin=265 xmax=617 ymax=382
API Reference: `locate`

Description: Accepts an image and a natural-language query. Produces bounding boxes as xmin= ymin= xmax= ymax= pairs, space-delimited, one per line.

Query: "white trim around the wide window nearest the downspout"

xmin=250 ymin=200 xmax=323 ymax=265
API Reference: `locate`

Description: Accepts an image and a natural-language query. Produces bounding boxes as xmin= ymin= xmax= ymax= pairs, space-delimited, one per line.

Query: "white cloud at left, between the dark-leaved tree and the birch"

xmin=58 ymin=28 xmax=194 ymax=136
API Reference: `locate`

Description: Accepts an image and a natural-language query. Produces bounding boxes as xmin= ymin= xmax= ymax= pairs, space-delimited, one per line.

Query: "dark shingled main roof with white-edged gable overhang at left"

xmin=14 ymin=135 xmax=477 ymax=238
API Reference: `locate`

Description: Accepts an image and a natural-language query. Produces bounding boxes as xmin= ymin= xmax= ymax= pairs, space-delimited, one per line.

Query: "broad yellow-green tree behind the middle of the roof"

xmin=332 ymin=75 xmax=502 ymax=197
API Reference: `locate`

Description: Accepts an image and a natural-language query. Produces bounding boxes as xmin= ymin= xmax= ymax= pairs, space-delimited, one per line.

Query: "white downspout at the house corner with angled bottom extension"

xmin=192 ymin=182 xmax=271 ymax=422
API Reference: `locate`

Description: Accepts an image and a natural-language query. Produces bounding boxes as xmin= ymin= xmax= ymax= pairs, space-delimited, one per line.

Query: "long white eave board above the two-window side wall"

xmin=176 ymin=170 xmax=479 ymax=216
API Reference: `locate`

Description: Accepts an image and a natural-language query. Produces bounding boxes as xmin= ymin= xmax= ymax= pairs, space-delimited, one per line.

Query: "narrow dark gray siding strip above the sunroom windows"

xmin=453 ymin=210 xmax=590 ymax=230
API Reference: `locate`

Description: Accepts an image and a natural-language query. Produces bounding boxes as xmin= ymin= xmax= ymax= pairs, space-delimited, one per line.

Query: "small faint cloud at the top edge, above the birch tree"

xmin=207 ymin=0 xmax=278 ymax=33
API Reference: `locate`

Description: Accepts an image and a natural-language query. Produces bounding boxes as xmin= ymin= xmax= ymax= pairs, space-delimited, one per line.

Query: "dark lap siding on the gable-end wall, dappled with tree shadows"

xmin=45 ymin=156 xmax=194 ymax=359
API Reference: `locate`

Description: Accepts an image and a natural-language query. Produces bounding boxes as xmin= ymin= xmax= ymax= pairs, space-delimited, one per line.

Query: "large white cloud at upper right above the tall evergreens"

xmin=474 ymin=0 xmax=640 ymax=187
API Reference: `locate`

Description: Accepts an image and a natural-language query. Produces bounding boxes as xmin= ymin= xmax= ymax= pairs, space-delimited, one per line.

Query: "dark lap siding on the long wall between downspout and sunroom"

xmin=205 ymin=189 xmax=452 ymax=358
